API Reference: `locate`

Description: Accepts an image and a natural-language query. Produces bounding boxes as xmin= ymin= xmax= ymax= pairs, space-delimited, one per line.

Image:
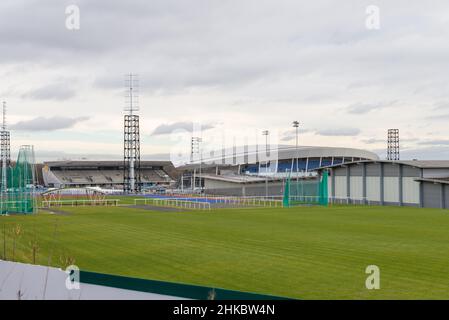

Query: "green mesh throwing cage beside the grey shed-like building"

xmin=283 ymin=171 xmax=329 ymax=207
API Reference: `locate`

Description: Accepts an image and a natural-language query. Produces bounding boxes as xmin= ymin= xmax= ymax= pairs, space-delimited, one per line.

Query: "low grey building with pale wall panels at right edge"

xmin=318 ymin=160 xmax=449 ymax=208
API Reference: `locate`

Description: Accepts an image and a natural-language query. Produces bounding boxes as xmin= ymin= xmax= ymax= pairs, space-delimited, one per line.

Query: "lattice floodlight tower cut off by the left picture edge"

xmin=0 ymin=101 xmax=11 ymax=214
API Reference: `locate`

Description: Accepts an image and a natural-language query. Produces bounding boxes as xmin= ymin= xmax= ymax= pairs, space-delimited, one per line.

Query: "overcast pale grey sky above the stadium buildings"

xmin=0 ymin=0 xmax=449 ymax=160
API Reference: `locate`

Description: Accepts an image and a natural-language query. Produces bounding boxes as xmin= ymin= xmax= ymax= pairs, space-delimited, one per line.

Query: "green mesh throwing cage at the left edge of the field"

xmin=0 ymin=146 xmax=36 ymax=214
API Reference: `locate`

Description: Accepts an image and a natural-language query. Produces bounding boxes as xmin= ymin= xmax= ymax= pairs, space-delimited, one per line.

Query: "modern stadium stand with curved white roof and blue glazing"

xmin=178 ymin=145 xmax=379 ymax=196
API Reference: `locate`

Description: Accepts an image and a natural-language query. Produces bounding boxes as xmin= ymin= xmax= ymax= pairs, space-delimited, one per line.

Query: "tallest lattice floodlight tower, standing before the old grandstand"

xmin=123 ymin=73 xmax=142 ymax=193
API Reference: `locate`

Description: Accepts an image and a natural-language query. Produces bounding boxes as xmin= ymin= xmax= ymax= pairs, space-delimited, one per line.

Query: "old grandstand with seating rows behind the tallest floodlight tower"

xmin=42 ymin=161 xmax=177 ymax=189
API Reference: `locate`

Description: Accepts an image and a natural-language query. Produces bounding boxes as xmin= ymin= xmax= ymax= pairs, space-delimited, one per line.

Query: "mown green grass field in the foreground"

xmin=0 ymin=207 xmax=449 ymax=299
